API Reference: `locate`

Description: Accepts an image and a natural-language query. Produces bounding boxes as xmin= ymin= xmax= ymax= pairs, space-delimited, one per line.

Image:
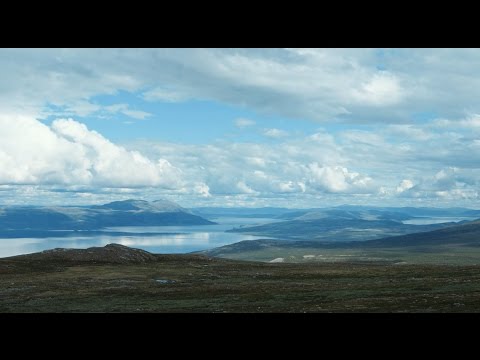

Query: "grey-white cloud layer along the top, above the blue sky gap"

xmin=0 ymin=49 xmax=480 ymax=123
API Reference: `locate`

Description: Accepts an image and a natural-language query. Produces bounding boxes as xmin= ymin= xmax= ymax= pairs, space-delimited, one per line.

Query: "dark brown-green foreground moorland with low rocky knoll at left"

xmin=0 ymin=245 xmax=480 ymax=313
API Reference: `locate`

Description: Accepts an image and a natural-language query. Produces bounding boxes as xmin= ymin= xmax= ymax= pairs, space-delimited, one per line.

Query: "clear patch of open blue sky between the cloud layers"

xmin=43 ymin=91 xmax=328 ymax=144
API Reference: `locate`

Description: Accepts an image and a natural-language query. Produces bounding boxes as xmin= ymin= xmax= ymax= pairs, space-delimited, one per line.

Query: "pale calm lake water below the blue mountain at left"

xmin=0 ymin=217 xmax=278 ymax=257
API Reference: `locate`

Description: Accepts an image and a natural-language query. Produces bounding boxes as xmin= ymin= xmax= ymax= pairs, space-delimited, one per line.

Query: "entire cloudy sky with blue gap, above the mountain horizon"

xmin=0 ymin=49 xmax=480 ymax=208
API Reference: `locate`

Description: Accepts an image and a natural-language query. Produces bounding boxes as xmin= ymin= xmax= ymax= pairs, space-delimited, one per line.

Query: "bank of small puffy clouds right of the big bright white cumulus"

xmin=117 ymin=109 xmax=480 ymax=206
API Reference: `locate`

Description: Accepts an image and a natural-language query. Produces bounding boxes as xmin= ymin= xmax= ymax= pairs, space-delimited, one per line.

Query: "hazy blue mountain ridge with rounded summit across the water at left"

xmin=0 ymin=200 xmax=214 ymax=231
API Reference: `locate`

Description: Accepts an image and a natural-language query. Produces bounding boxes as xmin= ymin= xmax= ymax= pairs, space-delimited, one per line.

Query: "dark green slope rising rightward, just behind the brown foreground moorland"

xmin=203 ymin=220 xmax=480 ymax=265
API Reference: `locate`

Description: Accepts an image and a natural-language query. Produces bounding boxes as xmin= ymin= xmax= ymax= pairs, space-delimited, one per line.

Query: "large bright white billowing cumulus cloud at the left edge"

xmin=0 ymin=116 xmax=181 ymax=188
